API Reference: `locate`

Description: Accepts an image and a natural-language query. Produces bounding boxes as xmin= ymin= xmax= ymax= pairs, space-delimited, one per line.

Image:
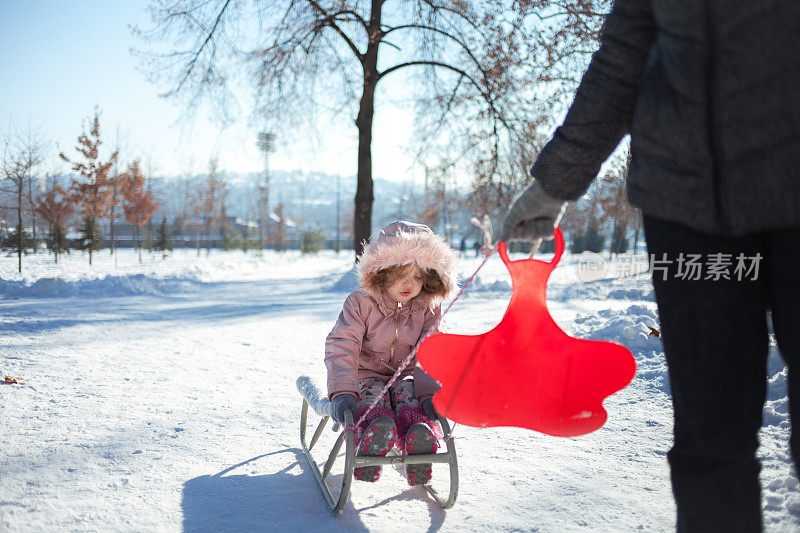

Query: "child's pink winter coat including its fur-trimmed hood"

xmin=325 ymin=220 xmax=457 ymax=401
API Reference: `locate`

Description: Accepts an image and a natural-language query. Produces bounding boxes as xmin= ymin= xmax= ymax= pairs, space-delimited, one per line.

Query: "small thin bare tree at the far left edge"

xmin=3 ymin=125 xmax=44 ymax=272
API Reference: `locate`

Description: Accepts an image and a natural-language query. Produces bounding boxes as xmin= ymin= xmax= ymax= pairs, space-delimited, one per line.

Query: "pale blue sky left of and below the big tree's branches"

xmin=0 ymin=0 xmax=412 ymax=180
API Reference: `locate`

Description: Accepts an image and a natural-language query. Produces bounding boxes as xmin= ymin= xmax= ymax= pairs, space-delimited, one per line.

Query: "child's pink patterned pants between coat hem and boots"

xmin=356 ymin=378 xmax=442 ymax=452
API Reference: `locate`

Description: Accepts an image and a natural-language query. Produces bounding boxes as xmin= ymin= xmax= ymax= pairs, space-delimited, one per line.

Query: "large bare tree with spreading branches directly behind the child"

xmin=135 ymin=0 xmax=556 ymax=255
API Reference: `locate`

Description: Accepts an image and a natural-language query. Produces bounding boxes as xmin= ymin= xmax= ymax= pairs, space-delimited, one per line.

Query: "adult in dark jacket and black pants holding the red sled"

xmin=501 ymin=0 xmax=800 ymax=531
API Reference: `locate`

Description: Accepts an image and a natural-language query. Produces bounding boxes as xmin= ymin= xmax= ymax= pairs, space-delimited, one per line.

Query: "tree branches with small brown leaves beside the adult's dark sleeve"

xmin=456 ymin=0 xmax=612 ymax=216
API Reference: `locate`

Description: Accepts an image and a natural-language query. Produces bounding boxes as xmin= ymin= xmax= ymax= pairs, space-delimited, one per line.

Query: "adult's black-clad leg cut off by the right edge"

xmin=765 ymin=229 xmax=800 ymax=470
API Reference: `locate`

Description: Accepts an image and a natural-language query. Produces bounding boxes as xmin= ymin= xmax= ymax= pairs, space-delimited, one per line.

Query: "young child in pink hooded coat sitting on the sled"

xmin=325 ymin=221 xmax=456 ymax=485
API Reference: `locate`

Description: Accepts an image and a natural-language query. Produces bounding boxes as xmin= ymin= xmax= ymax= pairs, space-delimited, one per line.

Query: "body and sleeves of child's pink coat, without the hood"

xmin=325 ymin=289 xmax=440 ymax=401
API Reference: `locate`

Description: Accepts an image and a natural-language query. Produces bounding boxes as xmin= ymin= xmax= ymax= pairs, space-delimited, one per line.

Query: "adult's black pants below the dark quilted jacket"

xmin=644 ymin=217 xmax=800 ymax=531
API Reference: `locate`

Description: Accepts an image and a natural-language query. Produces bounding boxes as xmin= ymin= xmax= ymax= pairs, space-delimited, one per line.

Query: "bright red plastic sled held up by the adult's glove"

xmin=417 ymin=230 xmax=636 ymax=437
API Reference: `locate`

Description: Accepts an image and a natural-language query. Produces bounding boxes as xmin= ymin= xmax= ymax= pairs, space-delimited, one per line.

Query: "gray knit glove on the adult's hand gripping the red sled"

xmin=500 ymin=181 xmax=567 ymax=242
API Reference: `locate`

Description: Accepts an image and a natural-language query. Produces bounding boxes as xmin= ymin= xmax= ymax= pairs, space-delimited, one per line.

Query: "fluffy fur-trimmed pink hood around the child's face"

xmin=356 ymin=220 xmax=458 ymax=308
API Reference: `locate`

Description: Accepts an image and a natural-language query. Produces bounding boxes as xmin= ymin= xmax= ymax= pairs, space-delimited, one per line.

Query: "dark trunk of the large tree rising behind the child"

xmin=353 ymin=0 xmax=383 ymax=257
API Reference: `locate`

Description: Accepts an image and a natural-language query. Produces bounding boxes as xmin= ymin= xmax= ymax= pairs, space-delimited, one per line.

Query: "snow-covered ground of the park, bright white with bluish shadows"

xmin=0 ymin=247 xmax=800 ymax=531
